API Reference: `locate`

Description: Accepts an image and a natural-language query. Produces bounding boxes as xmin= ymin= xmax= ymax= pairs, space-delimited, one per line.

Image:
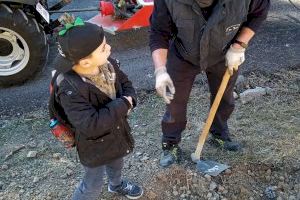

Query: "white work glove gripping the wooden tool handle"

xmin=225 ymin=45 xmax=246 ymax=75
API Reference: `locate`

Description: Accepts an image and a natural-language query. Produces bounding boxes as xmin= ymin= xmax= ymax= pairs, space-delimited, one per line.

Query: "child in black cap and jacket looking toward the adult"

xmin=55 ymin=18 xmax=143 ymax=200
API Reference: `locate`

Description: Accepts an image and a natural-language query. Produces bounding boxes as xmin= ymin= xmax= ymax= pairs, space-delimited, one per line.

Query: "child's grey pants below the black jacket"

xmin=72 ymin=158 xmax=123 ymax=200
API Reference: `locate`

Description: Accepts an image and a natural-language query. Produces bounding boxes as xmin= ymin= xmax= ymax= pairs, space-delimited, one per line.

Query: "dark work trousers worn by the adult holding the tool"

xmin=161 ymin=48 xmax=238 ymax=144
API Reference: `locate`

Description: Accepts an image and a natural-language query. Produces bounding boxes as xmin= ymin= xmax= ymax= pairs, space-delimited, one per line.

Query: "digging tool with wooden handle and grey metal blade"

xmin=191 ymin=67 xmax=237 ymax=176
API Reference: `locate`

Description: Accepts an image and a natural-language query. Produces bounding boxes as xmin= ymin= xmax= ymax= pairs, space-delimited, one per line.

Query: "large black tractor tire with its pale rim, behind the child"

xmin=0 ymin=4 xmax=49 ymax=86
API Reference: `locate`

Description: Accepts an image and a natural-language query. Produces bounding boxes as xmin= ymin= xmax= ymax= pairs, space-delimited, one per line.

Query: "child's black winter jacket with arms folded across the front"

xmin=57 ymin=59 xmax=136 ymax=167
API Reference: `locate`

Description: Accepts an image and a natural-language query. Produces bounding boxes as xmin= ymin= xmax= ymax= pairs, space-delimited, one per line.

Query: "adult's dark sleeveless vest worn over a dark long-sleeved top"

xmin=165 ymin=0 xmax=251 ymax=70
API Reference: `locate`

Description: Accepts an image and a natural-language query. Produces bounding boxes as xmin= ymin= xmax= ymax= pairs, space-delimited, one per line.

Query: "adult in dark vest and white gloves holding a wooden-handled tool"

xmin=149 ymin=0 xmax=270 ymax=167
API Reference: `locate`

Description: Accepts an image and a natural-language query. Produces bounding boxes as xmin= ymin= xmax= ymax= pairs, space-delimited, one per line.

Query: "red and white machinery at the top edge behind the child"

xmin=89 ymin=0 xmax=153 ymax=34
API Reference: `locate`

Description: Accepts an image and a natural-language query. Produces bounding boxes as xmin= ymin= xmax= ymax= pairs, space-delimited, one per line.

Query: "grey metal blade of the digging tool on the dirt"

xmin=197 ymin=160 xmax=230 ymax=176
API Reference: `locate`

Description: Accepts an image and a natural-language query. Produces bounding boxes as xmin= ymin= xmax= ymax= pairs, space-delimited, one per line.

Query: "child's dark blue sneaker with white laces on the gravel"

xmin=108 ymin=180 xmax=143 ymax=199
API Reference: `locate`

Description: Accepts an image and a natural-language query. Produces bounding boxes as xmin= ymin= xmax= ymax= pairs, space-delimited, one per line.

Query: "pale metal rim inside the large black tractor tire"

xmin=0 ymin=27 xmax=30 ymax=76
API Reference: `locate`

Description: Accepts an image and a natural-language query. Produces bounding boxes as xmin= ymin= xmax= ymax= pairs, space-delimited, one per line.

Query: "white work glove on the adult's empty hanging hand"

xmin=154 ymin=67 xmax=175 ymax=104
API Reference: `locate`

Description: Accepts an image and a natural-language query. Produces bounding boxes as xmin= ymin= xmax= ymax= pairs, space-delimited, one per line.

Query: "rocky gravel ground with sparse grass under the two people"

xmin=0 ymin=69 xmax=300 ymax=200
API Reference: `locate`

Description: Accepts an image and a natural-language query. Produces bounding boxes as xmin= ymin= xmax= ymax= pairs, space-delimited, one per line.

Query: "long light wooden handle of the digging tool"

xmin=195 ymin=69 xmax=230 ymax=159
